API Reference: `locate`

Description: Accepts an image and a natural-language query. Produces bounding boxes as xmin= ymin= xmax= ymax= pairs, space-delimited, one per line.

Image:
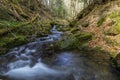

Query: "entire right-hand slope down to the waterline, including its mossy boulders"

xmin=52 ymin=0 xmax=120 ymax=70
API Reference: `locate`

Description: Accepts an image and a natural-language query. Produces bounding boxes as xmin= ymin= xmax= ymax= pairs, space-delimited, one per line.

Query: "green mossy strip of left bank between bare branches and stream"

xmin=0 ymin=20 xmax=51 ymax=54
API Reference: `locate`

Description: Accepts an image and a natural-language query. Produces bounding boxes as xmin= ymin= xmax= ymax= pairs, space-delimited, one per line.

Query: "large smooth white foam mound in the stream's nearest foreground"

xmin=4 ymin=63 xmax=74 ymax=80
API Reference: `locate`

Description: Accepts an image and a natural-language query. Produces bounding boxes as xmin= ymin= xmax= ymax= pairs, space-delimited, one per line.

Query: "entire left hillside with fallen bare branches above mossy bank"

xmin=0 ymin=0 xmax=54 ymax=54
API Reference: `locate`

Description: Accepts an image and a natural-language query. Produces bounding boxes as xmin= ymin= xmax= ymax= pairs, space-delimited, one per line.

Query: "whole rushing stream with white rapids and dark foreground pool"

xmin=0 ymin=25 xmax=120 ymax=80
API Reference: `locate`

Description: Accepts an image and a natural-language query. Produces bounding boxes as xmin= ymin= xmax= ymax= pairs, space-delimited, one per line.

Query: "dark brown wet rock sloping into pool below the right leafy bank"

xmin=81 ymin=47 xmax=111 ymax=66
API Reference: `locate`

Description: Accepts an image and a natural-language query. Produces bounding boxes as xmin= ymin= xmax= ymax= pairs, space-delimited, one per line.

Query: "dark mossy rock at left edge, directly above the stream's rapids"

xmin=0 ymin=35 xmax=28 ymax=54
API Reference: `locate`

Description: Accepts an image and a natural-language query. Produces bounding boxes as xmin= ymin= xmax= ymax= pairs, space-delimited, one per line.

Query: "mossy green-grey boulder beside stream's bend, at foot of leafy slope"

xmin=57 ymin=32 xmax=92 ymax=50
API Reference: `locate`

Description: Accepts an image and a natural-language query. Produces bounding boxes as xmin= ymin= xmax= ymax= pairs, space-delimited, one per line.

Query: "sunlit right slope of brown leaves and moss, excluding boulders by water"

xmin=70 ymin=0 xmax=120 ymax=56
